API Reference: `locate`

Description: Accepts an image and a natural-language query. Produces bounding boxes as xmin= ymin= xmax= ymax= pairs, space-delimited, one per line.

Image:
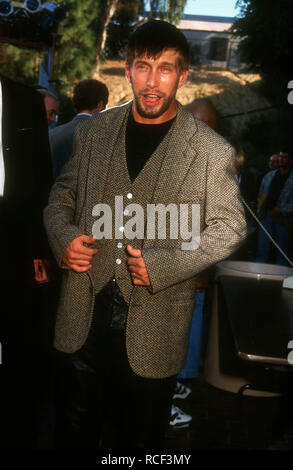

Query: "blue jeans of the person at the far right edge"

xmin=256 ymin=211 xmax=289 ymax=266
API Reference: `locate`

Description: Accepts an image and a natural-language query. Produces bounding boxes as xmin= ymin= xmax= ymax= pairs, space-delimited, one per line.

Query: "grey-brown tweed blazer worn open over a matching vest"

xmin=44 ymin=102 xmax=246 ymax=378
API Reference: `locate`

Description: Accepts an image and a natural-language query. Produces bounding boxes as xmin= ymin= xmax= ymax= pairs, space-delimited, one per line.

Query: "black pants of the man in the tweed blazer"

xmin=56 ymin=284 xmax=176 ymax=450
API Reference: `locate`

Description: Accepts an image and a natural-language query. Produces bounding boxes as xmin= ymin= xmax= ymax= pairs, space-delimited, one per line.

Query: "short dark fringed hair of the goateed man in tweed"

xmin=126 ymin=20 xmax=189 ymax=71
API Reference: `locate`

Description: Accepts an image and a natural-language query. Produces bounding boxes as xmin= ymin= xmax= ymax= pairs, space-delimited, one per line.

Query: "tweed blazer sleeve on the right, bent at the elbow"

xmin=143 ymin=142 xmax=247 ymax=293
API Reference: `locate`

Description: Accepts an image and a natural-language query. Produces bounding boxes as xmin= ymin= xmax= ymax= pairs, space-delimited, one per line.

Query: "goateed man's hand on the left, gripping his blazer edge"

xmin=62 ymin=235 xmax=98 ymax=273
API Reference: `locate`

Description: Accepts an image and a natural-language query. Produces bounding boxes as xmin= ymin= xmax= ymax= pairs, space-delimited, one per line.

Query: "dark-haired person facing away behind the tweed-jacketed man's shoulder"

xmin=49 ymin=78 xmax=109 ymax=179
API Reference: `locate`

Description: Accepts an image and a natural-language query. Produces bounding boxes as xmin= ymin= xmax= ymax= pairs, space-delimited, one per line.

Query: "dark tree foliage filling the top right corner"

xmin=233 ymin=0 xmax=293 ymax=101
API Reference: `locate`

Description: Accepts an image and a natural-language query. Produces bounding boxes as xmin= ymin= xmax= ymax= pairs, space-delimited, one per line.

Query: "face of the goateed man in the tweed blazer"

xmin=125 ymin=49 xmax=188 ymax=124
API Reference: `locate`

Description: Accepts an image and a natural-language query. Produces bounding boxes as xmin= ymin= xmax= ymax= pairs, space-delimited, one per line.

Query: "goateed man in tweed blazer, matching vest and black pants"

xmin=45 ymin=20 xmax=246 ymax=449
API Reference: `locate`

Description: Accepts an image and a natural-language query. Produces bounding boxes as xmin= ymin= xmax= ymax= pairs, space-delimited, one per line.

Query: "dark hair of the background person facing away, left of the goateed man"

xmin=73 ymin=78 xmax=109 ymax=113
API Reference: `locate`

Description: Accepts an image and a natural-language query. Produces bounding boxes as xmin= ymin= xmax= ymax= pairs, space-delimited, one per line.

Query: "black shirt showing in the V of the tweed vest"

xmin=126 ymin=113 xmax=175 ymax=182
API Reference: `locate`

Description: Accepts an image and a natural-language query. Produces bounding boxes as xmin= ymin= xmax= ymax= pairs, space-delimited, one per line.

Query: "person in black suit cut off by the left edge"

xmin=0 ymin=76 xmax=52 ymax=449
